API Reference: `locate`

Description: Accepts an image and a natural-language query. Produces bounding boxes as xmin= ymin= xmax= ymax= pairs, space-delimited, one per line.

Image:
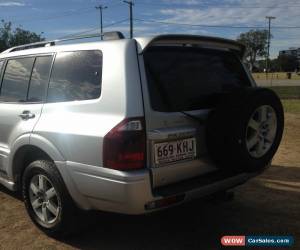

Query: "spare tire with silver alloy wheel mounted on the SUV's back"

xmin=206 ymin=88 xmax=284 ymax=172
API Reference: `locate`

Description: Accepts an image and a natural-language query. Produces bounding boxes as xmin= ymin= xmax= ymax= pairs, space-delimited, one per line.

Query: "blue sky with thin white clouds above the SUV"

xmin=0 ymin=0 xmax=300 ymax=57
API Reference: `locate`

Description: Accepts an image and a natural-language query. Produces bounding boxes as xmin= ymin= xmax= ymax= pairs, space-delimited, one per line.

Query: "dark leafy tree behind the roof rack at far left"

xmin=0 ymin=20 xmax=45 ymax=51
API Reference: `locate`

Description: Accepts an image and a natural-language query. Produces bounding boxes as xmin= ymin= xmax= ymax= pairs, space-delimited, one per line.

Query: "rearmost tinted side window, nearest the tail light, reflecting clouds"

xmin=48 ymin=50 xmax=102 ymax=102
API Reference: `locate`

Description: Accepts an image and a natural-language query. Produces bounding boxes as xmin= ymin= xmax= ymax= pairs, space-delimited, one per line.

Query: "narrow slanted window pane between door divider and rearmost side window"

xmin=27 ymin=56 xmax=52 ymax=102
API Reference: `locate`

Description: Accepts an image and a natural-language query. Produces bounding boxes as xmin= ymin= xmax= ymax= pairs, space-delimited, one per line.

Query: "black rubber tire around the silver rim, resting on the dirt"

xmin=22 ymin=160 xmax=77 ymax=238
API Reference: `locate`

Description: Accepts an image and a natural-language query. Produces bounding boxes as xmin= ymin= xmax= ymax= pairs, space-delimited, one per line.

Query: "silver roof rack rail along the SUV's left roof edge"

xmin=2 ymin=31 xmax=125 ymax=53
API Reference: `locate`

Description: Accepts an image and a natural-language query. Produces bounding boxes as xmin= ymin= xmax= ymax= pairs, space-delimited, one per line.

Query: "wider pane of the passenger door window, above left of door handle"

xmin=0 ymin=57 xmax=34 ymax=102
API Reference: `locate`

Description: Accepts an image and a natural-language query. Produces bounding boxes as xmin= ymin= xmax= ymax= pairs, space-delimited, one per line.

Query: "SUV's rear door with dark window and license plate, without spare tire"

xmin=140 ymin=34 xmax=251 ymax=188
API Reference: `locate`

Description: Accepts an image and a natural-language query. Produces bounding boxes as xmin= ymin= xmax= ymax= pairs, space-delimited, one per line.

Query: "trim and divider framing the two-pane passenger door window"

xmin=0 ymin=52 xmax=56 ymax=105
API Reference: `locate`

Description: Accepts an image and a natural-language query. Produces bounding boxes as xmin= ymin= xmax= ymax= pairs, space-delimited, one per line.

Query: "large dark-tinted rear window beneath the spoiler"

xmin=144 ymin=47 xmax=250 ymax=112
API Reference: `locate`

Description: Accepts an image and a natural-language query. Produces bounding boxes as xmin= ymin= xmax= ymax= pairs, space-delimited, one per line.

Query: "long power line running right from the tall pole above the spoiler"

xmin=134 ymin=18 xmax=300 ymax=29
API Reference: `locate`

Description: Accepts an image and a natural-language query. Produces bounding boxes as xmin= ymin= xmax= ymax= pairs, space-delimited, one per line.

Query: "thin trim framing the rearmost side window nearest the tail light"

xmin=45 ymin=49 xmax=103 ymax=104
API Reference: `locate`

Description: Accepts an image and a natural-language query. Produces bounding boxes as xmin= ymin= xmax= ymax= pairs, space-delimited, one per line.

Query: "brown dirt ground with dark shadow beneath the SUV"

xmin=0 ymin=114 xmax=300 ymax=250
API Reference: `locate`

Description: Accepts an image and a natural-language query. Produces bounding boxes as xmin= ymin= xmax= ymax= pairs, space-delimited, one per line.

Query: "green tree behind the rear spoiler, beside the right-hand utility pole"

xmin=237 ymin=30 xmax=268 ymax=71
